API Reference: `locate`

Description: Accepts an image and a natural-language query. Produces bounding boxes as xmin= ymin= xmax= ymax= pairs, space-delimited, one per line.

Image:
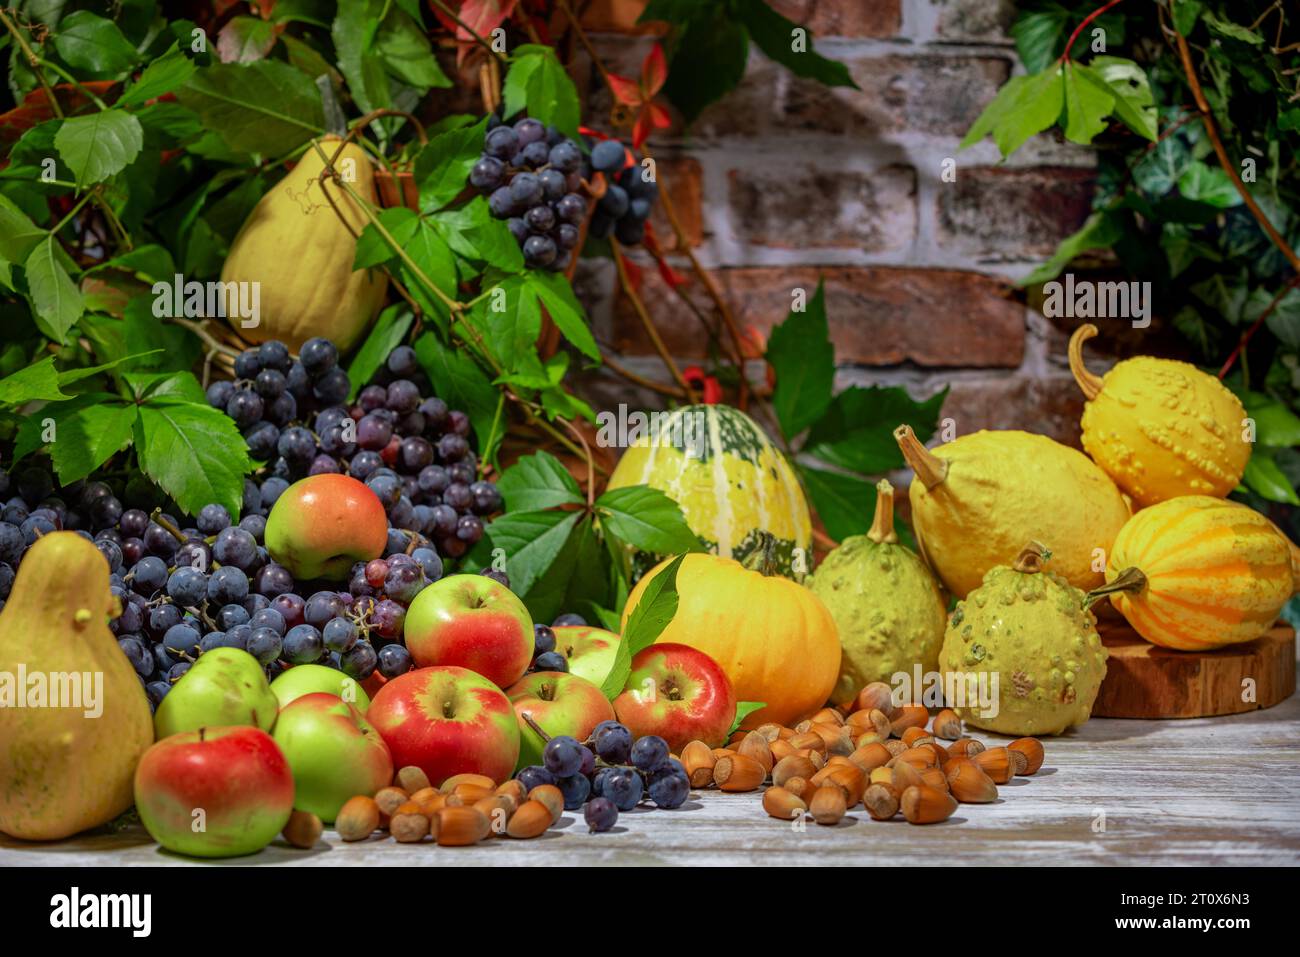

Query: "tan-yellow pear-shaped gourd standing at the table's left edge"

xmin=0 ymin=532 xmax=153 ymax=840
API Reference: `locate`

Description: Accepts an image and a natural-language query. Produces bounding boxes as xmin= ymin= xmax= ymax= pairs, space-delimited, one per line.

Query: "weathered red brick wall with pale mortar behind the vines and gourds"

xmin=577 ymin=0 xmax=1112 ymax=442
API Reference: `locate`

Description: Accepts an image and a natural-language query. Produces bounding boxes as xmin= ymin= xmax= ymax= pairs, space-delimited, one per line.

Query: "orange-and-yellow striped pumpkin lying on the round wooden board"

xmin=1089 ymin=495 xmax=1296 ymax=651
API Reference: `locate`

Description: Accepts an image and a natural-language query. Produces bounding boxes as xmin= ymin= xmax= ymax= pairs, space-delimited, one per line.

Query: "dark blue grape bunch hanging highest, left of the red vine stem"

xmin=469 ymin=116 xmax=588 ymax=272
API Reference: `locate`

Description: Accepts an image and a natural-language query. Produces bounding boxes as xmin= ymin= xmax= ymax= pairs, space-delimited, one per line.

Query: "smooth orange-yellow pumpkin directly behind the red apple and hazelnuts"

xmin=623 ymin=549 xmax=840 ymax=728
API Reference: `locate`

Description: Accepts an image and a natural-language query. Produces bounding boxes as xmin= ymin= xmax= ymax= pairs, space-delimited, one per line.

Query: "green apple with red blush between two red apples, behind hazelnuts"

xmin=274 ymin=692 xmax=393 ymax=823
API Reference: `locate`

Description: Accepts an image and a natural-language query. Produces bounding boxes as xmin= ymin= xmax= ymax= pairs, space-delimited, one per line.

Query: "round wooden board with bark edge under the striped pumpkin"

xmin=1092 ymin=622 xmax=1296 ymax=718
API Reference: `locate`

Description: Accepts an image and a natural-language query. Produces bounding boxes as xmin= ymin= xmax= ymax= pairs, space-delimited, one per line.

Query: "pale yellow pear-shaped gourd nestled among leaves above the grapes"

xmin=221 ymin=137 xmax=387 ymax=350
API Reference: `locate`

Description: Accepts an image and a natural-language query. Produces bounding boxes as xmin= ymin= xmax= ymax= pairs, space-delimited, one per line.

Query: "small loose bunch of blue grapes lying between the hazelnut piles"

xmin=515 ymin=720 xmax=690 ymax=831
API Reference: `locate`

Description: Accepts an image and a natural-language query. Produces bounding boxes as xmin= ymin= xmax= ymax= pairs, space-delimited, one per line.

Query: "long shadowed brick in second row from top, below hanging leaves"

xmin=692 ymin=53 xmax=1011 ymax=137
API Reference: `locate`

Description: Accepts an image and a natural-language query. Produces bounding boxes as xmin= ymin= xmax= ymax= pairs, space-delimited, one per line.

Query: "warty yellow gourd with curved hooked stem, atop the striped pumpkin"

xmin=1070 ymin=324 xmax=1251 ymax=506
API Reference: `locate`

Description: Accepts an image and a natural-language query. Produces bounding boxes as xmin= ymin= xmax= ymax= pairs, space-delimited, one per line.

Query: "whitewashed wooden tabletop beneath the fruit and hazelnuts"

xmin=0 ymin=642 xmax=1300 ymax=867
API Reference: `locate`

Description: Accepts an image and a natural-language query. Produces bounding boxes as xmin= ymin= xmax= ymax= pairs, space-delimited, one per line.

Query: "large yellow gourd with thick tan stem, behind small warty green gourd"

xmin=894 ymin=425 xmax=1128 ymax=598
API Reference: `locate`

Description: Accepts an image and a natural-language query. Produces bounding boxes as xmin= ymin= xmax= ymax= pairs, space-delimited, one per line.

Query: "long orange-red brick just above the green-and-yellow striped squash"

xmin=601 ymin=267 xmax=1026 ymax=368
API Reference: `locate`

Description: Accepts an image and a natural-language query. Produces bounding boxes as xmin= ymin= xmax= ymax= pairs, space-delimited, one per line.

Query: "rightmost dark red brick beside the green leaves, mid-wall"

xmin=936 ymin=166 xmax=1096 ymax=257
